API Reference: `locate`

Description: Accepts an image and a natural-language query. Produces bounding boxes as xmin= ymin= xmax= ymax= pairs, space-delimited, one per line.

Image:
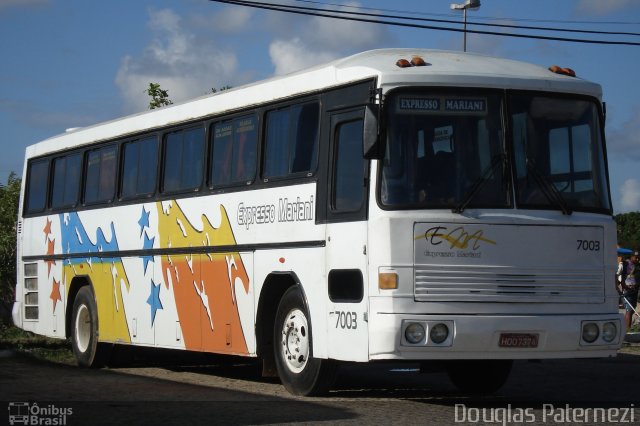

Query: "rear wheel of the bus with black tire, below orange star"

xmin=71 ymin=286 xmax=109 ymax=368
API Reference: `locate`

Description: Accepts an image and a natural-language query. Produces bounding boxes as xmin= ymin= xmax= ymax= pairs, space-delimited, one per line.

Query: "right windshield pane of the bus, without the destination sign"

xmin=511 ymin=94 xmax=611 ymax=213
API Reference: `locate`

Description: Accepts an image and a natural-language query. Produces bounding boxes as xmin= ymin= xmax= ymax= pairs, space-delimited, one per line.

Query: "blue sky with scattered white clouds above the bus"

xmin=0 ymin=0 xmax=640 ymax=214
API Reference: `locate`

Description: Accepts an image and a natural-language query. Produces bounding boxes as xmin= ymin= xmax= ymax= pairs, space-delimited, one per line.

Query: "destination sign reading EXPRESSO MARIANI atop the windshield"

xmin=398 ymin=97 xmax=487 ymax=114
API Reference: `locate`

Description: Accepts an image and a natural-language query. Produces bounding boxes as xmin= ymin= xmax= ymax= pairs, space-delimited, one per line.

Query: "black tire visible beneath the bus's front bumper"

xmin=446 ymin=360 xmax=513 ymax=395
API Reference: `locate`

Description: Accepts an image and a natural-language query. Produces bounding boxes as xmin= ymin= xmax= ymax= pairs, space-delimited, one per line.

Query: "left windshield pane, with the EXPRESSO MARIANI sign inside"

xmin=380 ymin=93 xmax=510 ymax=209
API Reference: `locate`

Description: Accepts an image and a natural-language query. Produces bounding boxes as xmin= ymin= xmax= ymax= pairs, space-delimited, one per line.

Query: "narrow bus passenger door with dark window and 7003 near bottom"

xmin=326 ymin=108 xmax=369 ymax=361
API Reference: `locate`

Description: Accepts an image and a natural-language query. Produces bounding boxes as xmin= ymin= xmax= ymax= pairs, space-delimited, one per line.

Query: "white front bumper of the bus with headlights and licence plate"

xmin=369 ymin=313 xmax=624 ymax=360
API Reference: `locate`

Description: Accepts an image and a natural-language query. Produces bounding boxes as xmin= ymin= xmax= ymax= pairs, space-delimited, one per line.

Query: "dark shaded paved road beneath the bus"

xmin=0 ymin=351 xmax=640 ymax=426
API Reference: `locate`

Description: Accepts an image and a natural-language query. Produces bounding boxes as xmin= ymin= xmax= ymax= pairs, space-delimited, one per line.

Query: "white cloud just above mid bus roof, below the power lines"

xmin=269 ymin=3 xmax=392 ymax=75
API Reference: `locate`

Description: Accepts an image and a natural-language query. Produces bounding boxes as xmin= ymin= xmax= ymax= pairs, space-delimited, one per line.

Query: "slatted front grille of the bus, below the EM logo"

xmin=414 ymin=265 xmax=604 ymax=303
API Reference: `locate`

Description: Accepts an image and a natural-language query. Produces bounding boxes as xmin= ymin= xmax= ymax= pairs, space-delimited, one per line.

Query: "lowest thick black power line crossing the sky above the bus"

xmin=209 ymin=0 xmax=640 ymax=46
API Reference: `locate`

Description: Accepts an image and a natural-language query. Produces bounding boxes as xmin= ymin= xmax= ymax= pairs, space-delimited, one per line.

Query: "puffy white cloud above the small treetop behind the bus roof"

xmin=116 ymin=9 xmax=240 ymax=111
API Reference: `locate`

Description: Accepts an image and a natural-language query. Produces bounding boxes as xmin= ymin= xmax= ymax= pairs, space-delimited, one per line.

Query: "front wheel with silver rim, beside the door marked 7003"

xmin=273 ymin=286 xmax=338 ymax=396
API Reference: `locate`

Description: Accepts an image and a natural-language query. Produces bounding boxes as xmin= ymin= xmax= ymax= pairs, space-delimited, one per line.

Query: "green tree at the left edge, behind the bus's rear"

xmin=0 ymin=172 xmax=20 ymax=320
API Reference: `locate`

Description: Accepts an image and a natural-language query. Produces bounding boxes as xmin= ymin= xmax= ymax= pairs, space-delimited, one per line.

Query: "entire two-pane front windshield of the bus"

xmin=380 ymin=91 xmax=610 ymax=214
